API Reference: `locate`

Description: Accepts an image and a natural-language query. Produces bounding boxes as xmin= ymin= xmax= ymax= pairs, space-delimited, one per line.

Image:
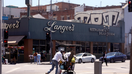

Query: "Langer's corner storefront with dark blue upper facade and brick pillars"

xmin=5 ymin=18 xmax=125 ymax=62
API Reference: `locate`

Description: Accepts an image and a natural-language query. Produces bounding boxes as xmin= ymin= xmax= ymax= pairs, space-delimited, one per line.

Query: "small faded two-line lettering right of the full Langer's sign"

xmin=90 ymin=28 xmax=115 ymax=36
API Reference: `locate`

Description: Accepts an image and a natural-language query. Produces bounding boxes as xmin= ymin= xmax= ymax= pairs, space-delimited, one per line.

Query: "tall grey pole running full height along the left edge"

xmin=0 ymin=0 xmax=2 ymax=74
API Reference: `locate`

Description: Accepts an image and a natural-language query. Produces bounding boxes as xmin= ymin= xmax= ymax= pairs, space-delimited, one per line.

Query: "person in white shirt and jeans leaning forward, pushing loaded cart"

xmin=45 ymin=48 xmax=64 ymax=74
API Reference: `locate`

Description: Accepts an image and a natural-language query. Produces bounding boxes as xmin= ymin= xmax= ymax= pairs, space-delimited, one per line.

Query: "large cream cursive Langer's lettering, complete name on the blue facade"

xmin=44 ymin=21 xmax=75 ymax=33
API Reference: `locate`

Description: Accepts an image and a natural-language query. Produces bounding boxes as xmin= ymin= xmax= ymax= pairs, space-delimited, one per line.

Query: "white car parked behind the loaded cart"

xmin=75 ymin=53 xmax=96 ymax=63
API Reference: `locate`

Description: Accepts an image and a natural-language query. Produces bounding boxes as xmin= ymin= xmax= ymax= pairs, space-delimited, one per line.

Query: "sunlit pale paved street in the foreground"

xmin=2 ymin=60 xmax=130 ymax=74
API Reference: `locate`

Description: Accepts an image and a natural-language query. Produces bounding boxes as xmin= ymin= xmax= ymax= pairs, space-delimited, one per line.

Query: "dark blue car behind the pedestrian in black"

xmin=99 ymin=52 xmax=127 ymax=63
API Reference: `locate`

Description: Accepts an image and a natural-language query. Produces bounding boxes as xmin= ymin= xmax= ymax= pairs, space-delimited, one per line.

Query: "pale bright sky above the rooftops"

xmin=4 ymin=0 xmax=126 ymax=7
